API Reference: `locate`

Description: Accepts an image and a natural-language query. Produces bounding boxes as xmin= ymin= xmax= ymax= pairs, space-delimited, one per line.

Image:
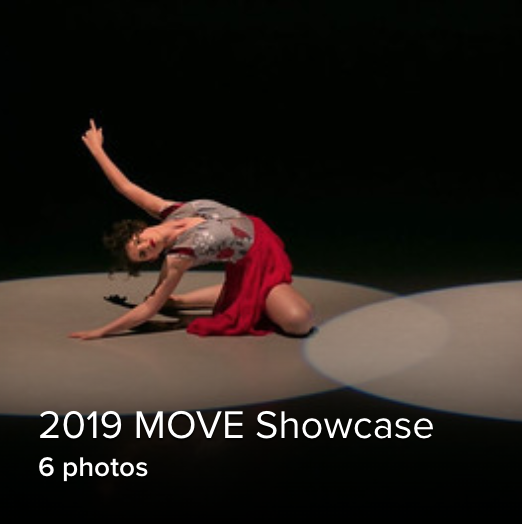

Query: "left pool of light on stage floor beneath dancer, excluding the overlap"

xmin=0 ymin=271 xmax=390 ymax=415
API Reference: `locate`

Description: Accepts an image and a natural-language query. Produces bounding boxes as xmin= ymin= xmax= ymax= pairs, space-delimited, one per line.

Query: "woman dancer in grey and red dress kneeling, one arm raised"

xmin=69 ymin=120 xmax=313 ymax=340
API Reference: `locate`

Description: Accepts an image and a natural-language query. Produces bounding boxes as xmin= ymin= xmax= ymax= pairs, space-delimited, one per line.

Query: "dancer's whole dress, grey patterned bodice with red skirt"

xmin=160 ymin=200 xmax=292 ymax=336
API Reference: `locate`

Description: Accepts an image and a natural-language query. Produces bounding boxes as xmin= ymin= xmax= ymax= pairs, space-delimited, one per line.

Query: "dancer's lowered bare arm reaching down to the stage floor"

xmin=69 ymin=257 xmax=192 ymax=340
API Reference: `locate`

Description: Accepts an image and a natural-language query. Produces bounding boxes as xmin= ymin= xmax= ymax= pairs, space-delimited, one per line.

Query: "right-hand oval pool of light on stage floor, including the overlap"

xmin=305 ymin=281 xmax=522 ymax=421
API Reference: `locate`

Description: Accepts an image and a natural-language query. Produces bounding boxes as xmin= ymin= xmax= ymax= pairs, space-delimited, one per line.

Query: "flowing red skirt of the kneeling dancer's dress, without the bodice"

xmin=187 ymin=216 xmax=292 ymax=336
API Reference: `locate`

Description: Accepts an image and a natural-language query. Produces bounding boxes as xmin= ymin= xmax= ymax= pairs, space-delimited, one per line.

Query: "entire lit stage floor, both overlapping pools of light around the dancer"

xmin=0 ymin=271 xmax=522 ymax=420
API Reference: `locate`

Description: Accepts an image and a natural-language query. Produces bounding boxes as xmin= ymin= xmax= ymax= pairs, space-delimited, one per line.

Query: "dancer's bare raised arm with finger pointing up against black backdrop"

xmin=82 ymin=119 xmax=172 ymax=217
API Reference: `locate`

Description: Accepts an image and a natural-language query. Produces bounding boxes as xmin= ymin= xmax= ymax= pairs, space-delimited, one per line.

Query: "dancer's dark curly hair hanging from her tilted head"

xmin=103 ymin=219 xmax=148 ymax=277
